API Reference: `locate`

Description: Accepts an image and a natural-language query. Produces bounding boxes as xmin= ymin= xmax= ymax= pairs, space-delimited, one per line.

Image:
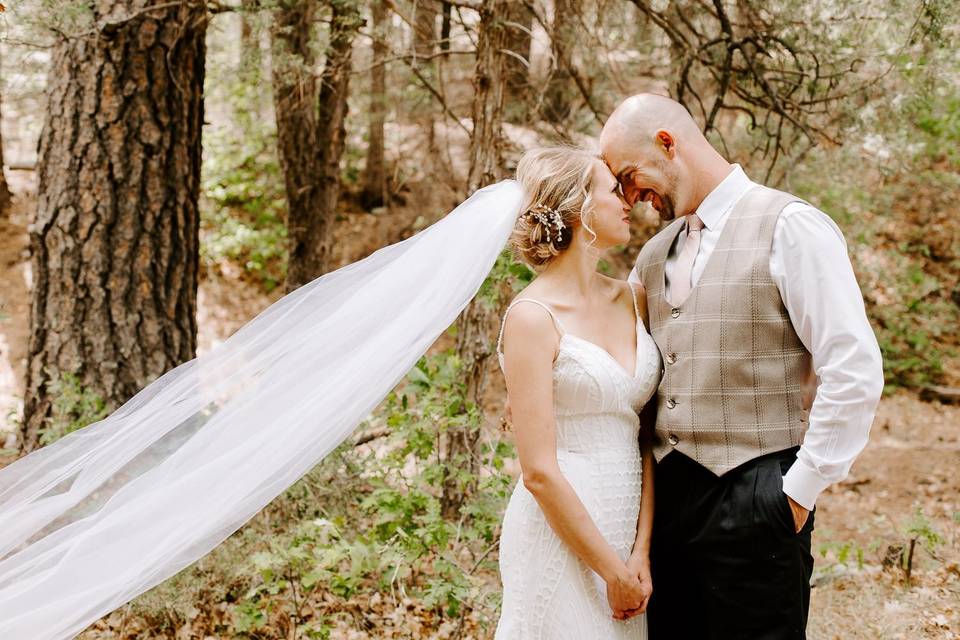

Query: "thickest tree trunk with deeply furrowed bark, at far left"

xmin=21 ymin=0 xmax=207 ymax=451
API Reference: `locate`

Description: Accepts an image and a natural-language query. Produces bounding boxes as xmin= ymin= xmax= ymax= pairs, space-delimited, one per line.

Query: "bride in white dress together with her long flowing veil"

xmin=0 ymin=149 xmax=660 ymax=640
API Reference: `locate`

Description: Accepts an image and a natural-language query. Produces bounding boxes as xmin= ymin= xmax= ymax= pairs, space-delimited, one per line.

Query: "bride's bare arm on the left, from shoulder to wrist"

xmin=503 ymin=304 xmax=636 ymax=608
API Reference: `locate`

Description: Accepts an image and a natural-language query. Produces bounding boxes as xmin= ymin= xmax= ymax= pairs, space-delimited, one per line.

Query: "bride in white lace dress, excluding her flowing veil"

xmin=496 ymin=149 xmax=660 ymax=640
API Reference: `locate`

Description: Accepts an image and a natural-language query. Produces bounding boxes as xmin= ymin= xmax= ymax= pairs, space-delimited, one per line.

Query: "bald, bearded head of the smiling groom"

xmin=600 ymin=93 xmax=717 ymax=220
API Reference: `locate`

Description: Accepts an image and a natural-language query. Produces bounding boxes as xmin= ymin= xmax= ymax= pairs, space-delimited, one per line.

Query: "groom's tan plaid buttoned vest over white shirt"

xmin=637 ymin=185 xmax=811 ymax=475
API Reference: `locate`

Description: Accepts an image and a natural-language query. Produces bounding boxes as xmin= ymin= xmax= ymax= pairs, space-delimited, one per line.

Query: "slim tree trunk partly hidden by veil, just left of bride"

xmin=441 ymin=0 xmax=515 ymax=517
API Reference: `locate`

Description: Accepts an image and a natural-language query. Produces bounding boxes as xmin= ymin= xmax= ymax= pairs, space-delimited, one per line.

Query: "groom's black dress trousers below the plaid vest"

xmin=647 ymin=447 xmax=814 ymax=640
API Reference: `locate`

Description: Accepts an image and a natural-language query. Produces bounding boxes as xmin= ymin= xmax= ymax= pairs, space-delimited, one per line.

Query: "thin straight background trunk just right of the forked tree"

xmin=363 ymin=0 xmax=387 ymax=208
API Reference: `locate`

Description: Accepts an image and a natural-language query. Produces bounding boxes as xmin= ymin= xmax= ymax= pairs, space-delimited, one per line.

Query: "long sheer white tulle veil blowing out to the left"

xmin=0 ymin=180 xmax=522 ymax=640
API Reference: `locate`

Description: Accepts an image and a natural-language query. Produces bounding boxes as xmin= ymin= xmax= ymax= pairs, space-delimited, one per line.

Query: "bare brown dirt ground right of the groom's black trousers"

xmin=810 ymin=393 xmax=960 ymax=640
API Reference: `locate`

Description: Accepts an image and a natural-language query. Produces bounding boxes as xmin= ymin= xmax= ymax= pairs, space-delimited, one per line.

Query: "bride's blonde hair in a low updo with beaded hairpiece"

xmin=510 ymin=147 xmax=601 ymax=267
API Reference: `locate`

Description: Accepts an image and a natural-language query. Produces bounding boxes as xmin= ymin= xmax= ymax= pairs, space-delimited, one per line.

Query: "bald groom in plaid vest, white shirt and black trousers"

xmin=600 ymin=94 xmax=883 ymax=640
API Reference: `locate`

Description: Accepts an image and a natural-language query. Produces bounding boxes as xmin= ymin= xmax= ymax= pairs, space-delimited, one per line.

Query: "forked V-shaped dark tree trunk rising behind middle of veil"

xmin=272 ymin=0 xmax=360 ymax=292
